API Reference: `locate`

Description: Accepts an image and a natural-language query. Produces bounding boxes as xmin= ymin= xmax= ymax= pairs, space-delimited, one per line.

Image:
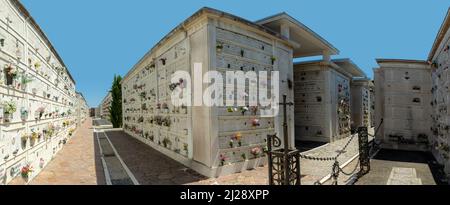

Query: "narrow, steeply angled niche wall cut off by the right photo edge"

xmin=431 ymin=27 xmax=450 ymax=176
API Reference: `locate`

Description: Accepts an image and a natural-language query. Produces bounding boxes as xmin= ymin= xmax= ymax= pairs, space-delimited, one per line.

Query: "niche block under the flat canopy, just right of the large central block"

xmin=295 ymin=62 xmax=350 ymax=142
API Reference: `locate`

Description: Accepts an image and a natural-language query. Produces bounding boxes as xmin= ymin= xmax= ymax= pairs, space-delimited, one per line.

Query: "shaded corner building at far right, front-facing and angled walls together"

xmin=374 ymin=9 xmax=450 ymax=181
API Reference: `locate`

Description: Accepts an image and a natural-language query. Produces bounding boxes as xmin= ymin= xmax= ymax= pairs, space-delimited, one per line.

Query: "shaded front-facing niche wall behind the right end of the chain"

xmin=375 ymin=62 xmax=433 ymax=150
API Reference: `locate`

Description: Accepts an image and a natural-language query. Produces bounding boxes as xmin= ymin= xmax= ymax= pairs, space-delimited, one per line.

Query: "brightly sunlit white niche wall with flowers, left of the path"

xmin=0 ymin=0 xmax=76 ymax=184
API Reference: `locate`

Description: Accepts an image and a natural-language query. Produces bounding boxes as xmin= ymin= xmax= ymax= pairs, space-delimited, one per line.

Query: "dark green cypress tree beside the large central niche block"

xmin=109 ymin=75 xmax=122 ymax=128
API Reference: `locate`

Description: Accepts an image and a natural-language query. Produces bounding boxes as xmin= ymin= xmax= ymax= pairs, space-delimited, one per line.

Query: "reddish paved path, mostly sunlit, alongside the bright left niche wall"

xmin=30 ymin=118 xmax=105 ymax=185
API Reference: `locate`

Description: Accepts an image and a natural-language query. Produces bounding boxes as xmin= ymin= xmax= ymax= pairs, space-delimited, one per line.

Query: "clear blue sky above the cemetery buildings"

xmin=22 ymin=0 xmax=449 ymax=106
